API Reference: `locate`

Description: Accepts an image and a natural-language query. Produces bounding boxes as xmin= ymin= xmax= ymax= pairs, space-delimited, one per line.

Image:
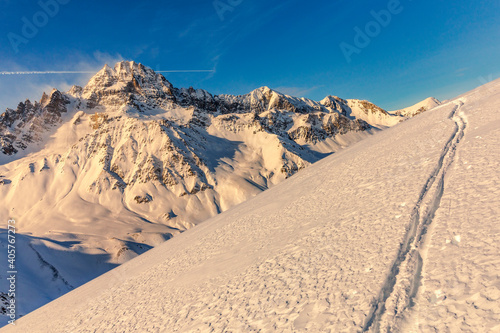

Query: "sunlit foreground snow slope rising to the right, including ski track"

xmin=2 ymin=80 xmax=500 ymax=332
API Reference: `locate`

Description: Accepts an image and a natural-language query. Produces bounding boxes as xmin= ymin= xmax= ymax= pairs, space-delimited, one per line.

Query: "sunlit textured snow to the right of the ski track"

xmin=410 ymin=87 xmax=500 ymax=333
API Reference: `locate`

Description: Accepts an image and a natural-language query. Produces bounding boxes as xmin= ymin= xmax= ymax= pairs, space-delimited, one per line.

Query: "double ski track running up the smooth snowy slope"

xmin=363 ymin=101 xmax=466 ymax=332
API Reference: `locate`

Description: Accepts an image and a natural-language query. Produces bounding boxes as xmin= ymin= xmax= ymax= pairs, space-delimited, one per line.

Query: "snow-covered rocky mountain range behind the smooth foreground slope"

xmin=0 ymin=61 xmax=438 ymax=322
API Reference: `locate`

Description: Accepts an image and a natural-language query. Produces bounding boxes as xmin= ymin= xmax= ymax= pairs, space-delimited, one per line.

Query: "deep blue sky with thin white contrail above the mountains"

xmin=0 ymin=0 xmax=500 ymax=110
